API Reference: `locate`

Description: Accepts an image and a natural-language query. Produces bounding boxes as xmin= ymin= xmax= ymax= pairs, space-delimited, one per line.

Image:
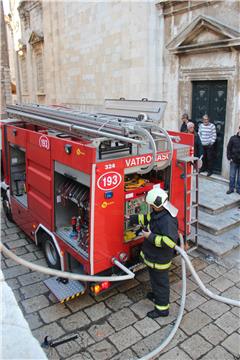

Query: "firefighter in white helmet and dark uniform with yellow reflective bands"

xmin=130 ymin=187 xmax=178 ymax=319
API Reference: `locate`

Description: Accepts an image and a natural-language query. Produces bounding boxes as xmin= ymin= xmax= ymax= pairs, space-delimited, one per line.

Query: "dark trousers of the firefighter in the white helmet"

xmin=148 ymin=268 xmax=170 ymax=306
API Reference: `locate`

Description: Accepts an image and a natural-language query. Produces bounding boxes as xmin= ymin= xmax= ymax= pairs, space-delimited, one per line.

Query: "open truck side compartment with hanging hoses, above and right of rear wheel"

xmin=54 ymin=162 xmax=90 ymax=258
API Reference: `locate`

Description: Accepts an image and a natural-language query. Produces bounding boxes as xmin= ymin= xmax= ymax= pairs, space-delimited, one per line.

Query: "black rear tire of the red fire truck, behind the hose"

xmin=41 ymin=233 xmax=61 ymax=270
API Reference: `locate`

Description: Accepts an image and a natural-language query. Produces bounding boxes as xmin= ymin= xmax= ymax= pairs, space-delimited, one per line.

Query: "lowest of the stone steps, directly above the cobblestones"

xmin=195 ymin=228 xmax=240 ymax=257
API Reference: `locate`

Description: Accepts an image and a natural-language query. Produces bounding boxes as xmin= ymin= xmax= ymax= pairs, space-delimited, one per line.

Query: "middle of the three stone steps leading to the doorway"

xmin=199 ymin=208 xmax=240 ymax=237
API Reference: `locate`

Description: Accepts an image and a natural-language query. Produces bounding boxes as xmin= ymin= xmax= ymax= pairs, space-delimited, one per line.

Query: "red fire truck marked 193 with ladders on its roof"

xmin=1 ymin=99 xmax=198 ymax=301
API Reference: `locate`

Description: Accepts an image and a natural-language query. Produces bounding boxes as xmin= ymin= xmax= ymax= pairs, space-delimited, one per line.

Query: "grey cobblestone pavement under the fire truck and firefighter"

xmin=1 ymin=215 xmax=240 ymax=360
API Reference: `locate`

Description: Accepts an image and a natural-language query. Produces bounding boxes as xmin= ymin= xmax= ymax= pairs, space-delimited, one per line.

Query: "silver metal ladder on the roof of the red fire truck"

xmin=6 ymin=99 xmax=174 ymax=174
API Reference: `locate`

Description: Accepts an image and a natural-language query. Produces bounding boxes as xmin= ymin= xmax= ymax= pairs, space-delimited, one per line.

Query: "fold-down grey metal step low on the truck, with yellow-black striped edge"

xmin=44 ymin=276 xmax=86 ymax=303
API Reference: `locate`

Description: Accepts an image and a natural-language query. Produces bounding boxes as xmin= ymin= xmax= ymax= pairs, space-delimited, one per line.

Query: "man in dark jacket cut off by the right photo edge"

xmin=227 ymin=126 xmax=240 ymax=194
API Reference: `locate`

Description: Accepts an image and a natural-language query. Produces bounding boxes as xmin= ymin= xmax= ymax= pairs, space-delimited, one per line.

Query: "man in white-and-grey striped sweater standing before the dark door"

xmin=198 ymin=114 xmax=217 ymax=176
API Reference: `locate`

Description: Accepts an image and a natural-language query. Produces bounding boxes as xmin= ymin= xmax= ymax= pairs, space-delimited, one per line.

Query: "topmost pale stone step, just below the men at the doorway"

xmin=199 ymin=177 xmax=240 ymax=214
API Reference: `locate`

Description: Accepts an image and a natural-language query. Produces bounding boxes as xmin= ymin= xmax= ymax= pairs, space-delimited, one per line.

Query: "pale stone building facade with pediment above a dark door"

xmin=7 ymin=0 xmax=240 ymax=176
